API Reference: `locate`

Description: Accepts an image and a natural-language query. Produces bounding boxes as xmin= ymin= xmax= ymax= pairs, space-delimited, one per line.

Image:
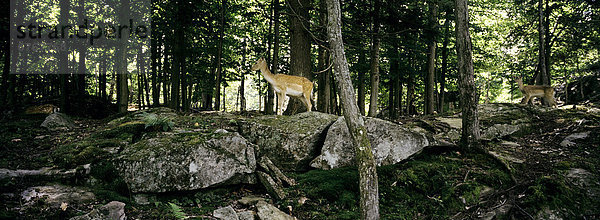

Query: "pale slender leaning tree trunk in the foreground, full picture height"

xmin=327 ymin=0 xmax=379 ymax=219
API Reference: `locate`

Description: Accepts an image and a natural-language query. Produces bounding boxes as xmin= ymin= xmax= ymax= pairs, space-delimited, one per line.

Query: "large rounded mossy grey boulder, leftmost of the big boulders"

xmin=115 ymin=130 xmax=256 ymax=192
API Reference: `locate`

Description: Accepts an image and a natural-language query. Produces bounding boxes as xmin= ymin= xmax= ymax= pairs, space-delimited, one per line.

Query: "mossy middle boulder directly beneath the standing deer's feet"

xmin=240 ymin=112 xmax=338 ymax=171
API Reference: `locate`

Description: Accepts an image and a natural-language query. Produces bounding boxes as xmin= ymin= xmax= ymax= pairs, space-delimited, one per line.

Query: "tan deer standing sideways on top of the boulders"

xmin=251 ymin=58 xmax=313 ymax=115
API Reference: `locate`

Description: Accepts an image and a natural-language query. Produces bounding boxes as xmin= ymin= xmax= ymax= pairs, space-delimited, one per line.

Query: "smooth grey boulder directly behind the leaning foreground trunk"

xmin=310 ymin=117 xmax=429 ymax=169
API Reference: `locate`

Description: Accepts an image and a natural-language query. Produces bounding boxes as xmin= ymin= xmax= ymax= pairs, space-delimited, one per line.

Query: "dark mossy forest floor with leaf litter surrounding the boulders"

xmin=0 ymin=104 xmax=600 ymax=219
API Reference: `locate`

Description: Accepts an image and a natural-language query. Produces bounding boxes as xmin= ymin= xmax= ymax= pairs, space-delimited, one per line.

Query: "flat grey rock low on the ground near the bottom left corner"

xmin=21 ymin=184 xmax=96 ymax=208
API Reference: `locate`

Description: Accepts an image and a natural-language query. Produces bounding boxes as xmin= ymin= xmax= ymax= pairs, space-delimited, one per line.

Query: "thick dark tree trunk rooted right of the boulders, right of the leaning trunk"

xmin=456 ymin=0 xmax=479 ymax=150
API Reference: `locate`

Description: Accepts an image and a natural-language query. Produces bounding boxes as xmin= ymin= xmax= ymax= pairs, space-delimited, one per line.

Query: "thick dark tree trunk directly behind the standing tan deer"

xmin=284 ymin=0 xmax=312 ymax=115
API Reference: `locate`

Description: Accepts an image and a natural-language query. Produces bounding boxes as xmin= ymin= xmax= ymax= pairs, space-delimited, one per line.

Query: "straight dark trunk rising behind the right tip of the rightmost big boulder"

xmin=425 ymin=0 xmax=438 ymax=115
